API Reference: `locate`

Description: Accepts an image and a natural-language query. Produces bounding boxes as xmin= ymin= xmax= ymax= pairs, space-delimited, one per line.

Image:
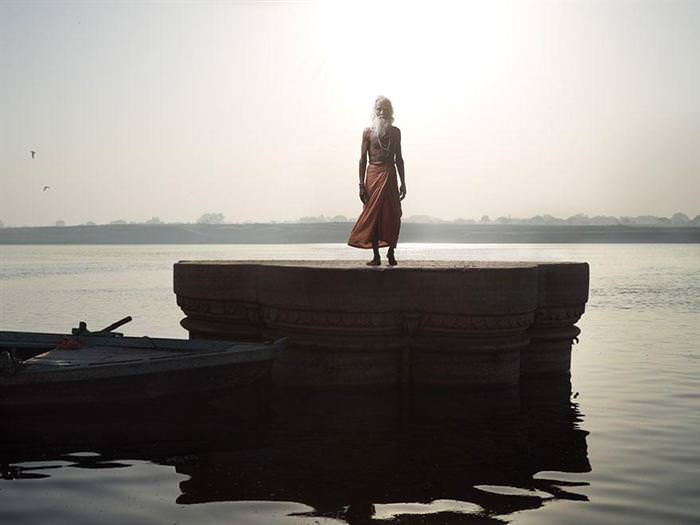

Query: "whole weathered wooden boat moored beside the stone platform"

xmin=0 ymin=323 xmax=286 ymax=409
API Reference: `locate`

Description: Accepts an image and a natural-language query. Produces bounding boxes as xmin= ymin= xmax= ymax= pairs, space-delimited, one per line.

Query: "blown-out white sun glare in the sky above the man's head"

xmin=319 ymin=2 xmax=515 ymax=125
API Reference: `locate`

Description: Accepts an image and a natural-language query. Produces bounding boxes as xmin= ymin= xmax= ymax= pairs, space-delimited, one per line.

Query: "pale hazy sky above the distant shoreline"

xmin=0 ymin=0 xmax=700 ymax=225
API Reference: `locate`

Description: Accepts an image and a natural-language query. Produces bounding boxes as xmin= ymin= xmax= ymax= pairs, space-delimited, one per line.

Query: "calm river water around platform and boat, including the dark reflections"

xmin=0 ymin=244 xmax=700 ymax=525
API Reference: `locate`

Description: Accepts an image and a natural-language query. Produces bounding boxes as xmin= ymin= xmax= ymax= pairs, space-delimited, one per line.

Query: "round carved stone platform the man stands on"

xmin=175 ymin=261 xmax=588 ymax=387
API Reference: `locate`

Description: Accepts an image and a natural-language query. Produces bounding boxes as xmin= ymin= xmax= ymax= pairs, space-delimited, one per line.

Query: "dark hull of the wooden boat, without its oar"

xmin=0 ymin=332 xmax=284 ymax=409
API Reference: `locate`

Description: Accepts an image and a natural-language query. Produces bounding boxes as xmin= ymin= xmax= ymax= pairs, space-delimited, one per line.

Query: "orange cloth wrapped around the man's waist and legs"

xmin=348 ymin=164 xmax=401 ymax=248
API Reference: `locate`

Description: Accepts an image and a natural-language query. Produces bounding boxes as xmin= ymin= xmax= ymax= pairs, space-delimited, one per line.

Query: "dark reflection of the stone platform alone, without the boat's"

xmin=175 ymin=378 xmax=591 ymax=524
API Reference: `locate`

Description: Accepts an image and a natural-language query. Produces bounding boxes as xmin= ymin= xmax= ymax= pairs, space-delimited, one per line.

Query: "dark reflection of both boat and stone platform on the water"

xmin=0 ymin=381 xmax=590 ymax=524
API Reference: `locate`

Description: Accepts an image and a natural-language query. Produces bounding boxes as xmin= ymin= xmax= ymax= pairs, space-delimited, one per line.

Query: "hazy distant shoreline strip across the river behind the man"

xmin=0 ymin=222 xmax=700 ymax=245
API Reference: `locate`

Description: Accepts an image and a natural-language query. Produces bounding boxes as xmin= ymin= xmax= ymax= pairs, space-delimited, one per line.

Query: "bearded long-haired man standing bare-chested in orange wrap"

xmin=348 ymin=96 xmax=406 ymax=266
